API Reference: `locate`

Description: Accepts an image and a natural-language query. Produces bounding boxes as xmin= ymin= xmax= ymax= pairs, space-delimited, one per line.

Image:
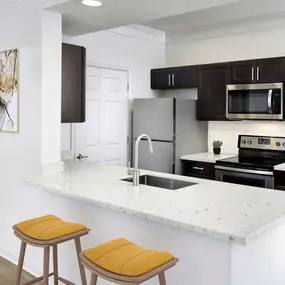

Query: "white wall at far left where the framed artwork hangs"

xmin=0 ymin=0 xmax=63 ymax=276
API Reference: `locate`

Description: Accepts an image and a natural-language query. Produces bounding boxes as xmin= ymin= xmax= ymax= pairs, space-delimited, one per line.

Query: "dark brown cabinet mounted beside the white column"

xmin=61 ymin=43 xmax=86 ymax=123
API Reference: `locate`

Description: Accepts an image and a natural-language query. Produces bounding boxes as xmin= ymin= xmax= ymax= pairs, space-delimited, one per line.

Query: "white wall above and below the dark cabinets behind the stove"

xmin=166 ymin=27 xmax=285 ymax=153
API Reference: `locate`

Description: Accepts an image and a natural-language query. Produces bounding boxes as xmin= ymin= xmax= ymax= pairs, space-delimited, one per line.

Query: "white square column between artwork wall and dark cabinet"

xmin=41 ymin=11 xmax=62 ymax=165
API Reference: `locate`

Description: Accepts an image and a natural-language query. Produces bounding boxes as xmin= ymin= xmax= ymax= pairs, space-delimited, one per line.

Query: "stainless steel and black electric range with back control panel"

xmin=215 ymin=135 xmax=285 ymax=189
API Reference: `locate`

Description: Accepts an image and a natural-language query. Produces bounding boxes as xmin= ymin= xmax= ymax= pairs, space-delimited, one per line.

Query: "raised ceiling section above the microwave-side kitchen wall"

xmin=143 ymin=0 xmax=285 ymax=35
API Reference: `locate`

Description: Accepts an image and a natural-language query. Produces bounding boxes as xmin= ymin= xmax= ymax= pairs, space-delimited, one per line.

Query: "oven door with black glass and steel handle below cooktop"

xmin=215 ymin=165 xmax=274 ymax=189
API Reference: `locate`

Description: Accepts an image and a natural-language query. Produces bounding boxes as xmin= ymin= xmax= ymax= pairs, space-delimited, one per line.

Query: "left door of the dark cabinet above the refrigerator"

xmin=151 ymin=68 xmax=174 ymax=90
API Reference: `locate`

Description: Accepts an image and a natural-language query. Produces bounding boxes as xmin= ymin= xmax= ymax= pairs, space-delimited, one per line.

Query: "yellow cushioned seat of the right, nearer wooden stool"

xmin=83 ymin=238 xmax=174 ymax=277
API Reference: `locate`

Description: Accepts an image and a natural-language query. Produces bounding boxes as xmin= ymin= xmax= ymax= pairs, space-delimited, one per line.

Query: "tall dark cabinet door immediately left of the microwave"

xmin=197 ymin=63 xmax=229 ymax=121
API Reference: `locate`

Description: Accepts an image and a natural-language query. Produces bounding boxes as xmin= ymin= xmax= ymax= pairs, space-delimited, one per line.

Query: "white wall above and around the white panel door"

xmin=62 ymin=26 xmax=165 ymax=152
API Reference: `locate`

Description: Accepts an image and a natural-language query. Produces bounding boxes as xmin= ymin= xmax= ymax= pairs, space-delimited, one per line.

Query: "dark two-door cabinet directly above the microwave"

xmin=230 ymin=57 xmax=285 ymax=84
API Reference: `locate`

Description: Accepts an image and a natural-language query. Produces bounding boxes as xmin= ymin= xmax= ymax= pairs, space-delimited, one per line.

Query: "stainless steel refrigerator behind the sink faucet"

xmin=132 ymin=98 xmax=208 ymax=174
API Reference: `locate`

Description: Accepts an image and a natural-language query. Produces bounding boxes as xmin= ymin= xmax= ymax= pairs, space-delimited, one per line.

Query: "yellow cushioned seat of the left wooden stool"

xmin=16 ymin=215 xmax=87 ymax=241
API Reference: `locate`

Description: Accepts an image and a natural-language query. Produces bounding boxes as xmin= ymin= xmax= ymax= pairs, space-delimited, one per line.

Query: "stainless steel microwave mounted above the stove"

xmin=226 ymin=83 xmax=284 ymax=120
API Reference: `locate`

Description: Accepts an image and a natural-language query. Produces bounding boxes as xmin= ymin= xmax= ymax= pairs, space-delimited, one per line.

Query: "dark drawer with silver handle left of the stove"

xmin=182 ymin=160 xmax=215 ymax=180
